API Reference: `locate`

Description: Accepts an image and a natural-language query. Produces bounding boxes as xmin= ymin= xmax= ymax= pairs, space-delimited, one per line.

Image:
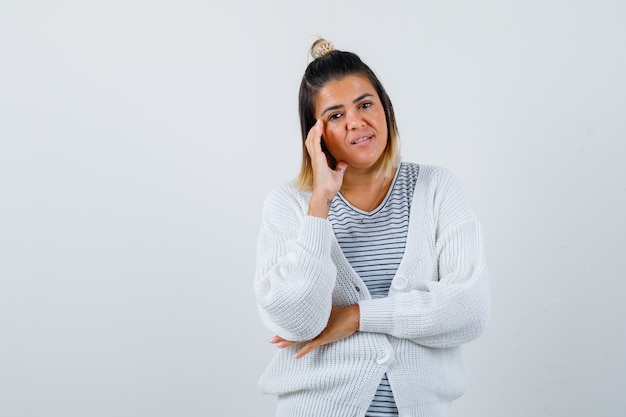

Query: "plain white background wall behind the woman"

xmin=0 ymin=0 xmax=626 ymax=417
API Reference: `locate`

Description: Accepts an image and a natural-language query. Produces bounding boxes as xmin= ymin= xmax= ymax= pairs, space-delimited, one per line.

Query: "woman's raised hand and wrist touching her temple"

xmin=304 ymin=120 xmax=348 ymax=219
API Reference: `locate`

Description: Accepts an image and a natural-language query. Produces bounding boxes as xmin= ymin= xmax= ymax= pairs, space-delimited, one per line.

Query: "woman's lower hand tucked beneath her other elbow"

xmin=270 ymin=304 xmax=359 ymax=359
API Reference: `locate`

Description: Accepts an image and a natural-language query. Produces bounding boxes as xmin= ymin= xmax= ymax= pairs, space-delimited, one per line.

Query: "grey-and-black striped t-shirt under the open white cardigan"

xmin=328 ymin=163 xmax=419 ymax=417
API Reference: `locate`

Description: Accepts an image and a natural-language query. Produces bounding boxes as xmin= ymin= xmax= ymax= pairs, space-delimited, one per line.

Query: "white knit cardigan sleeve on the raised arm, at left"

xmin=254 ymin=185 xmax=336 ymax=341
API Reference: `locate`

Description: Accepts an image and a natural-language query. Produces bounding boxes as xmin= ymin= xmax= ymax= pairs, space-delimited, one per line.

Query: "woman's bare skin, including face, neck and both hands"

xmin=270 ymin=75 xmax=392 ymax=359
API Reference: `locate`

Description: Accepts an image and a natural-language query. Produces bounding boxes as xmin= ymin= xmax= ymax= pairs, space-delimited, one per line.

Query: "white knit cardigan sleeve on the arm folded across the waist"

xmin=359 ymin=169 xmax=491 ymax=348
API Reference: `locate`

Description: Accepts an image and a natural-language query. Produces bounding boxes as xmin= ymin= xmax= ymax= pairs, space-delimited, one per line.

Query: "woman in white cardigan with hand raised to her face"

xmin=255 ymin=40 xmax=490 ymax=417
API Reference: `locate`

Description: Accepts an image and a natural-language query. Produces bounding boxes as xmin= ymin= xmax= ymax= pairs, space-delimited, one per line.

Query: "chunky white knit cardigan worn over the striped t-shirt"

xmin=254 ymin=165 xmax=490 ymax=417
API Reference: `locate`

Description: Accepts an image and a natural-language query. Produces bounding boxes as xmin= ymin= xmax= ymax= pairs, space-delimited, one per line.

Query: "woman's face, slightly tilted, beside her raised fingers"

xmin=315 ymin=75 xmax=388 ymax=172
